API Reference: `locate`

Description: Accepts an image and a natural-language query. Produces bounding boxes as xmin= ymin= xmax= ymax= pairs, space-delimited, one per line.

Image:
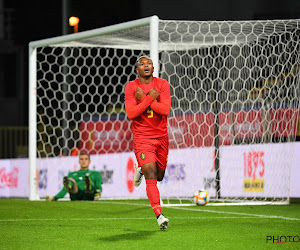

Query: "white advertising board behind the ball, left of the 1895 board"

xmin=159 ymin=147 xmax=216 ymax=197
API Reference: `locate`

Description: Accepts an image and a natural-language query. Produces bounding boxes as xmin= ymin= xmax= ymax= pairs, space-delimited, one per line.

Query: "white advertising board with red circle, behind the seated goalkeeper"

xmin=37 ymin=153 xmax=146 ymax=198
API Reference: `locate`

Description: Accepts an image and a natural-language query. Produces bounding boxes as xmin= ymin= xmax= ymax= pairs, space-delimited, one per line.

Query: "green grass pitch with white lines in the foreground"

xmin=0 ymin=199 xmax=300 ymax=250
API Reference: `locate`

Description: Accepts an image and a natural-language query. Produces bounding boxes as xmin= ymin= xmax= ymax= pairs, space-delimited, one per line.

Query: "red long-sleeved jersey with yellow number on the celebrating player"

xmin=125 ymin=77 xmax=171 ymax=139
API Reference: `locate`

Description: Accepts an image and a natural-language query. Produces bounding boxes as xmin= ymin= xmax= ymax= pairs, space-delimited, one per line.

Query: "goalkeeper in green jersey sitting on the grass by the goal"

xmin=46 ymin=152 xmax=102 ymax=201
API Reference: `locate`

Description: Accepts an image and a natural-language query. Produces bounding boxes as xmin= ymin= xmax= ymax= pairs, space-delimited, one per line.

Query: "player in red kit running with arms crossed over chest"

xmin=125 ymin=56 xmax=171 ymax=230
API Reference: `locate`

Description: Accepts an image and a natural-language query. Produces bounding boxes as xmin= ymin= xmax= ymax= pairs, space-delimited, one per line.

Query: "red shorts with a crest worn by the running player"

xmin=133 ymin=135 xmax=169 ymax=170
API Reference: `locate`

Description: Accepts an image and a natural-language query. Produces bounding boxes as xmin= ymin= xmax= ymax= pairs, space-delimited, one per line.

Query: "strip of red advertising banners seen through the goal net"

xmin=80 ymin=108 xmax=298 ymax=154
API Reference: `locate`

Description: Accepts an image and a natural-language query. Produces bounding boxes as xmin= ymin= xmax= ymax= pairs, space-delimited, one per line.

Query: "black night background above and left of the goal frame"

xmin=0 ymin=0 xmax=300 ymax=126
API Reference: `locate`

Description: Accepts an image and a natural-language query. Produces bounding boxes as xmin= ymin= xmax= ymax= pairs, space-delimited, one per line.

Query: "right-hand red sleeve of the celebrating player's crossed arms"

xmin=150 ymin=81 xmax=171 ymax=116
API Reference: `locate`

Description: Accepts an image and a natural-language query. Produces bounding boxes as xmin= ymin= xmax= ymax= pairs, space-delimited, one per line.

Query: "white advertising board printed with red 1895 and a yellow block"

xmin=220 ymin=143 xmax=300 ymax=198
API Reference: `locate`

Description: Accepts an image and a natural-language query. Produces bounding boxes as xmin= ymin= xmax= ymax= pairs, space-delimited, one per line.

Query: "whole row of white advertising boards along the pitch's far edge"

xmin=0 ymin=143 xmax=300 ymax=198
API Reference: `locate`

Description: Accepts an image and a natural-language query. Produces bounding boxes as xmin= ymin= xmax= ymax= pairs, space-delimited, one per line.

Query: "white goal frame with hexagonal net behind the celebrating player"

xmin=29 ymin=16 xmax=300 ymax=203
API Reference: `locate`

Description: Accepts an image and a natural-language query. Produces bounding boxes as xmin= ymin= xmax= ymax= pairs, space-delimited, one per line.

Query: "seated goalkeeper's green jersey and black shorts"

xmin=55 ymin=169 xmax=102 ymax=200
